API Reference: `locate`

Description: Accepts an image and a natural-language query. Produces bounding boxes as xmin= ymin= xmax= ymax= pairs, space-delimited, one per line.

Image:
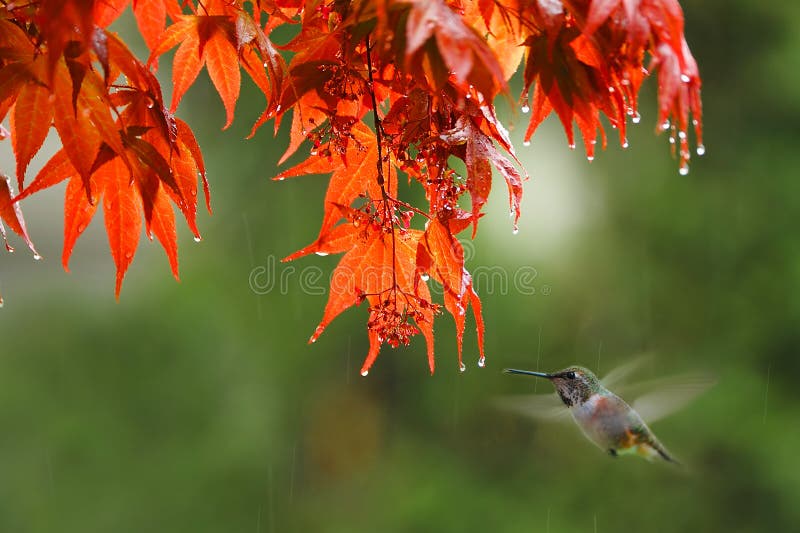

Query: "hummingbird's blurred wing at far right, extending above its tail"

xmin=631 ymin=374 xmax=716 ymax=423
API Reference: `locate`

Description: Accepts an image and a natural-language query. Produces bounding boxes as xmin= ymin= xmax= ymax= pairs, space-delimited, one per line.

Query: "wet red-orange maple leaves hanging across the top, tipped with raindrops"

xmin=0 ymin=0 xmax=704 ymax=375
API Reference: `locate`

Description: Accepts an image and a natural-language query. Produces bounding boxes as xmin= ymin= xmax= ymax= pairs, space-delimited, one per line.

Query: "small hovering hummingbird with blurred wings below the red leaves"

xmin=499 ymin=362 xmax=711 ymax=464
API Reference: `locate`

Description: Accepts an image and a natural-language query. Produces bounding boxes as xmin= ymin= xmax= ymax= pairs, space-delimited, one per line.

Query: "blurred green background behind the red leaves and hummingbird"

xmin=0 ymin=0 xmax=800 ymax=533
